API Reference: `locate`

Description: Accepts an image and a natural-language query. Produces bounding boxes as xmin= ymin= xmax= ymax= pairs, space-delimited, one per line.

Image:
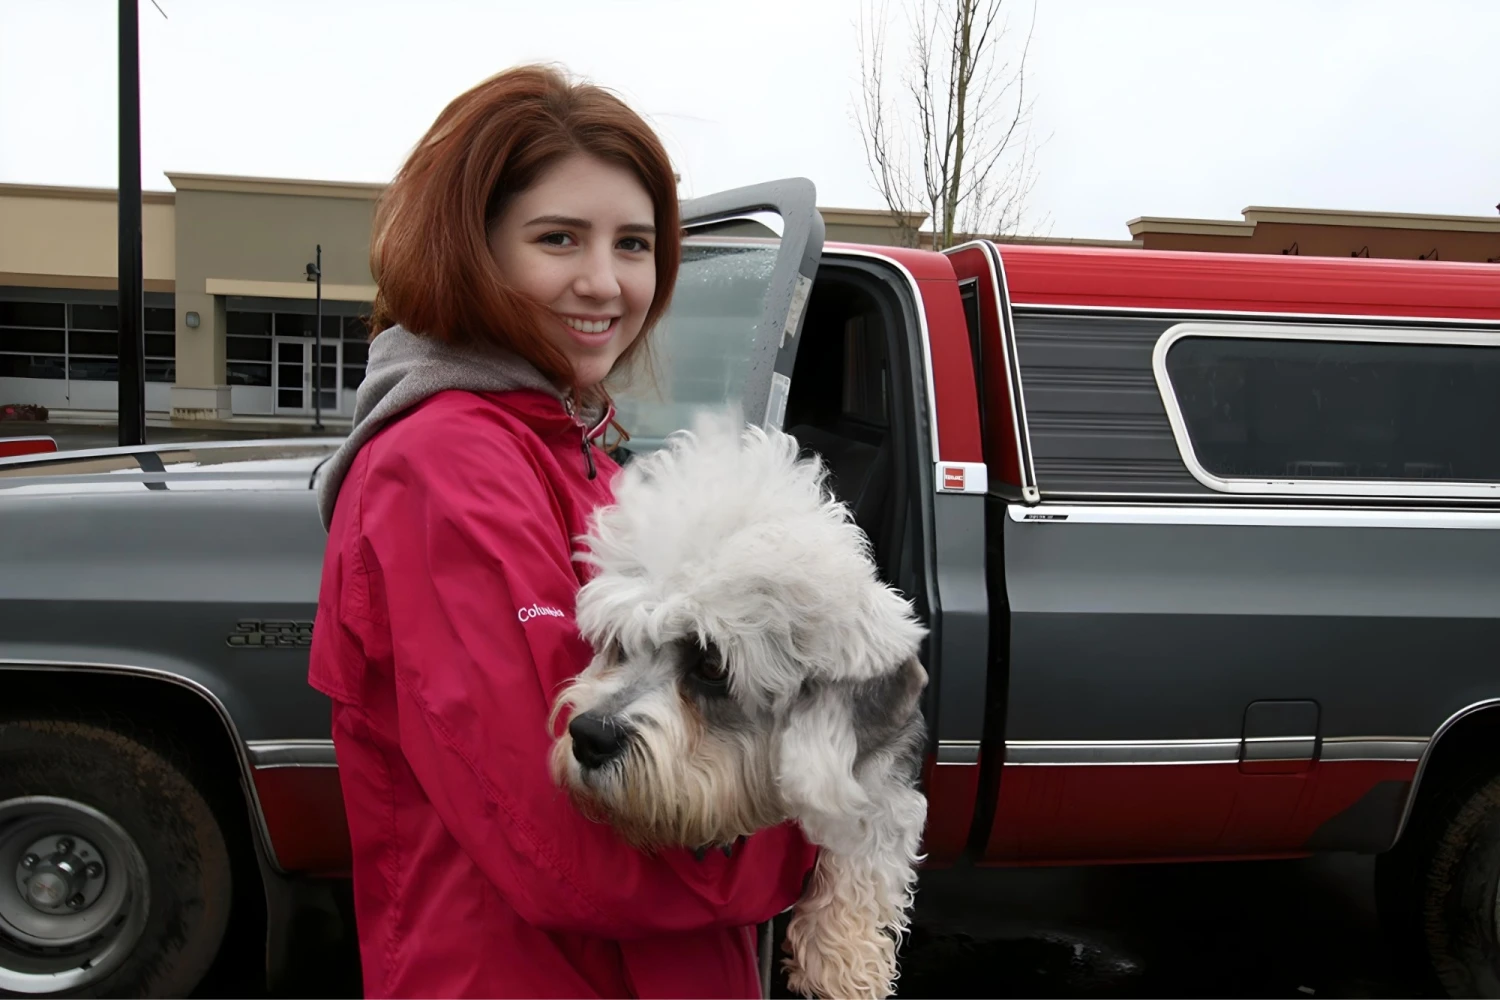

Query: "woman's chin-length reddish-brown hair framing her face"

xmin=371 ymin=66 xmax=683 ymax=398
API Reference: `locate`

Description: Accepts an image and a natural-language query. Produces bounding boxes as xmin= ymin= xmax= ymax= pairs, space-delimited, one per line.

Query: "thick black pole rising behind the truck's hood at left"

xmin=117 ymin=0 xmax=146 ymax=445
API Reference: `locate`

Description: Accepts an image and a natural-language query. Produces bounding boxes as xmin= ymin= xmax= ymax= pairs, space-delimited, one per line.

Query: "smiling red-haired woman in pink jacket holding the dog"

xmin=311 ymin=67 xmax=813 ymax=997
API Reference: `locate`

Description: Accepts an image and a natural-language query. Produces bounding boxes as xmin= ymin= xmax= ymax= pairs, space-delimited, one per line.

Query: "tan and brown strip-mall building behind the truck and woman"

xmin=0 ymin=174 xmax=1500 ymax=421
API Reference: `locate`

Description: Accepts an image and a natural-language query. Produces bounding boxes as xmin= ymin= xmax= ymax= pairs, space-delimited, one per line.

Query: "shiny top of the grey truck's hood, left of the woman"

xmin=0 ymin=438 xmax=342 ymax=498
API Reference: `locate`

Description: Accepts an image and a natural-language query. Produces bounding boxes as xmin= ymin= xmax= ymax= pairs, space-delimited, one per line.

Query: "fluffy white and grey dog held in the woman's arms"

xmin=552 ymin=418 xmax=927 ymax=997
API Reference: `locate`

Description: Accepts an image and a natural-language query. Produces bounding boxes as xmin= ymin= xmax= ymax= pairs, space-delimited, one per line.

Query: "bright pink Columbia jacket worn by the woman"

xmin=309 ymin=388 xmax=815 ymax=997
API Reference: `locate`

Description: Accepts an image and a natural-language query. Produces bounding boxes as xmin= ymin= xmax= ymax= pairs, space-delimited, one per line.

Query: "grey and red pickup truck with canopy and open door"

xmin=0 ymin=178 xmax=1500 ymax=996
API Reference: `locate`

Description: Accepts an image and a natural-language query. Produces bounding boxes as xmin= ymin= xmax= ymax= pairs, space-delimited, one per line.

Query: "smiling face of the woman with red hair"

xmin=489 ymin=153 xmax=656 ymax=388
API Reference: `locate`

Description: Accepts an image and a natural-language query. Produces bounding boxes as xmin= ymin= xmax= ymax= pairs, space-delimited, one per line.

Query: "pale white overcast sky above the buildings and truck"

xmin=0 ymin=0 xmax=1500 ymax=238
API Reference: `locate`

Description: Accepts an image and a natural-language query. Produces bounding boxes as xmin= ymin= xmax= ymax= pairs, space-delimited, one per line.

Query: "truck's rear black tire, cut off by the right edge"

xmin=1377 ymin=774 xmax=1500 ymax=997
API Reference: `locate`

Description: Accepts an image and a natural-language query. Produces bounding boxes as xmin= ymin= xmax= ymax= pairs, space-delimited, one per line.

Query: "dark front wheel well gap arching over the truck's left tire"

xmin=0 ymin=667 xmax=266 ymax=959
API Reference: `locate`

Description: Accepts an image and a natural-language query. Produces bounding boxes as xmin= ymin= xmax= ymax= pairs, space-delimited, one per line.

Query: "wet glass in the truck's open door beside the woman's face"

xmin=614 ymin=237 xmax=780 ymax=453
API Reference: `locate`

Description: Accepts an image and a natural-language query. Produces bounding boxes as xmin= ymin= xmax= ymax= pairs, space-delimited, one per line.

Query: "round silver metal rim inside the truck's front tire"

xmin=0 ymin=796 xmax=150 ymax=994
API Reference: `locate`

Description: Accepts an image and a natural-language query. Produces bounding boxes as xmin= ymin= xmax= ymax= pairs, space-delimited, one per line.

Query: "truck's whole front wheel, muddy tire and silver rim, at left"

xmin=0 ymin=721 xmax=230 ymax=997
